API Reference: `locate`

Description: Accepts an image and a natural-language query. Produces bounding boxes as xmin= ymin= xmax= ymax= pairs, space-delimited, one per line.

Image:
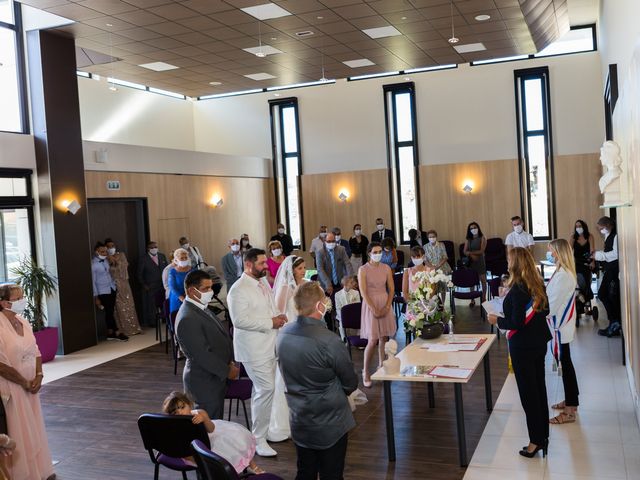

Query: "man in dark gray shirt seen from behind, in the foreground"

xmin=277 ymin=282 xmax=358 ymax=480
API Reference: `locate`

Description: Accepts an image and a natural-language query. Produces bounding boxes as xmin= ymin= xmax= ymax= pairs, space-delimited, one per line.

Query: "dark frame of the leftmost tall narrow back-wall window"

xmin=269 ymin=97 xmax=305 ymax=250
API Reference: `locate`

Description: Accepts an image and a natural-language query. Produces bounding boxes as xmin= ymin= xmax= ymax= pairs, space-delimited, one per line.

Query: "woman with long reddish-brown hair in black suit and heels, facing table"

xmin=488 ymin=247 xmax=551 ymax=458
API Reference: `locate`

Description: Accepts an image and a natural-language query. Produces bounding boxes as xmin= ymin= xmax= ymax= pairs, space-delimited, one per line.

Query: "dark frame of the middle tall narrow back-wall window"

xmin=382 ymin=82 xmax=422 ymax=245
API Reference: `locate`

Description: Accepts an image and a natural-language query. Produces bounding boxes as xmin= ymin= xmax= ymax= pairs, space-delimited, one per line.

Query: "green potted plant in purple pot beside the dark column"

xmin=11 ymin=256 xmax=58 ymax=363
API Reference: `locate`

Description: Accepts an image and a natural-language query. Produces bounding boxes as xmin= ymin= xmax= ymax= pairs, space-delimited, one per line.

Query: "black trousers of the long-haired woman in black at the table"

xmin=509 ymin=348 xmax=549 ymax=445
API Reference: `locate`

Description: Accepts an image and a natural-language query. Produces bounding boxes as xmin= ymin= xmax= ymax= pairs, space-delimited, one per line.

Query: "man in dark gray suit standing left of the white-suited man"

xmin=176 ymin=270 xmax=239 ymax=419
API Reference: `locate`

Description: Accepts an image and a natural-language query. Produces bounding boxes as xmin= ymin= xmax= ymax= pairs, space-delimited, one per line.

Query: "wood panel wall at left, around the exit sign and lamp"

xmin=85 ymin=171 xmax=276 ymax=269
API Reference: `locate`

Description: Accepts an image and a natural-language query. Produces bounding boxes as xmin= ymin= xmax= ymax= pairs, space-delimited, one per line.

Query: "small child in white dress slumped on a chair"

xmin=162 ymin=392 xmax=265 ymax=475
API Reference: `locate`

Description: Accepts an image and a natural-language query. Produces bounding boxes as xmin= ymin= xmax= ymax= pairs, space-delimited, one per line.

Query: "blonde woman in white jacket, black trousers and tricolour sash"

xmin=547 ymin=239 xmax=579 ymax=425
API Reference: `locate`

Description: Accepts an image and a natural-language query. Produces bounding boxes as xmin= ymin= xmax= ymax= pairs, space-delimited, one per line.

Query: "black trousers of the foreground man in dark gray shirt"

xmin=296 ymin=433 xmax=347 ymax=480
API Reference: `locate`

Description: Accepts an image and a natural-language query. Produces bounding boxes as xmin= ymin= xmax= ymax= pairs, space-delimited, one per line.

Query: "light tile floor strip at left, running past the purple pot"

xmin=42 ymin=328 xmax=158 ymax=384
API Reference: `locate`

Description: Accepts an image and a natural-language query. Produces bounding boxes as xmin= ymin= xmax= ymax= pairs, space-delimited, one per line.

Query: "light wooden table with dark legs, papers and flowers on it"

xmin=371 ymin=334 xmax=496 ymax=467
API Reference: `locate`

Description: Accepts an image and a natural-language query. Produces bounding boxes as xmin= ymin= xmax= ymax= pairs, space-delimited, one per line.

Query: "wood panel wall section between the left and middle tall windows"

xmin=301 ymin=169 xmax=391 ymax=249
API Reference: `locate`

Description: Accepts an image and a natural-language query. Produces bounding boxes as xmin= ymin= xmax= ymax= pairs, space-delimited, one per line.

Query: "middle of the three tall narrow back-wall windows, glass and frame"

xmin=384 ymin=82 xmax=420 ymax=243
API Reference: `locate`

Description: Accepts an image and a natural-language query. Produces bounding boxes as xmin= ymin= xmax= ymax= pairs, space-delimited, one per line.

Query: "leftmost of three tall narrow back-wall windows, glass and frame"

xmin=269 ymin=98 xmax=304 ymax=248
